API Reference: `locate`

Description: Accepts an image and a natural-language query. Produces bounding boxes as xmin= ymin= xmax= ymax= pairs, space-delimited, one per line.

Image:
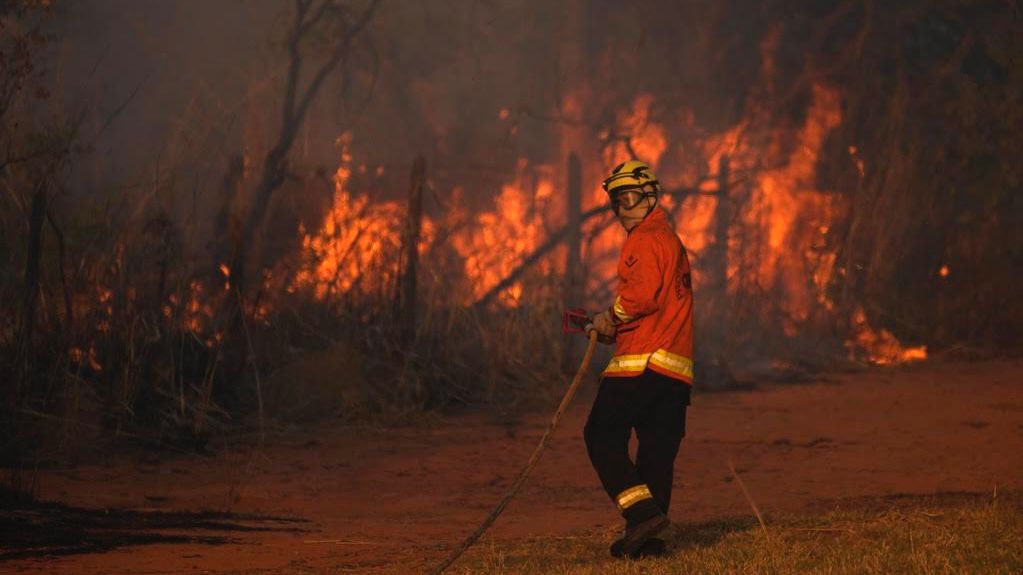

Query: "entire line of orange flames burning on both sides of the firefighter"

xmin=290 ymin=42 xmax=928 ymax=363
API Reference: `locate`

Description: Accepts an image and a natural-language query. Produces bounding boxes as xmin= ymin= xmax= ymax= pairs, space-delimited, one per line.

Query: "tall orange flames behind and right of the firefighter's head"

xmin=594 ymin=81 xmax=928 ymax=363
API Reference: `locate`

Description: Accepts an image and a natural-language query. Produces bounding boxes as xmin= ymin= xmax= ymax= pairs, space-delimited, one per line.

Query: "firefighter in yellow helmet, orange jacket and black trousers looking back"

xmin=583 ymin=160 xmax=693 ymax=558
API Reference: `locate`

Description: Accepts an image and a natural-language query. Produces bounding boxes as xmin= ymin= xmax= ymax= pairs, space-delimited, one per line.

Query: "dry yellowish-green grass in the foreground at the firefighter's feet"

xmin=449 ymin=494 xmax=1023 ymax=575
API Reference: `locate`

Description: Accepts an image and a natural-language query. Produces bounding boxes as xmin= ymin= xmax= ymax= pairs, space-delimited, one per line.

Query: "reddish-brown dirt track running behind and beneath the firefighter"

xmin=0 ymin=360 xmax=1023 ymax=575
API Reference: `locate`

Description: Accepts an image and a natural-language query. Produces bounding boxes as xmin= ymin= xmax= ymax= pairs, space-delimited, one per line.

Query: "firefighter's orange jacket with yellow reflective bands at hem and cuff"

xmin=604 ymin=203 xmax=693 ymax=385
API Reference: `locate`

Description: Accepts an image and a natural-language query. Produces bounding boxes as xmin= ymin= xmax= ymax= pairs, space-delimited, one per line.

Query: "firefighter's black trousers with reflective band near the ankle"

xmin=583 ymin=369 xmax=690 ymax=517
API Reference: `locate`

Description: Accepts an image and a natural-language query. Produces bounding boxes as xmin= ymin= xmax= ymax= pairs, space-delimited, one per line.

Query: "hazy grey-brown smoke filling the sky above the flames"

xmin=39 ymin=0 xmax=763 ymax=214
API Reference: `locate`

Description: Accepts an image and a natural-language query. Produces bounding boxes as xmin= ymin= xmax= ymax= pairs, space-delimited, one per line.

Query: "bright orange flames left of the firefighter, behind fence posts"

xmin=288 ymin=141 xmax=555 ymax=306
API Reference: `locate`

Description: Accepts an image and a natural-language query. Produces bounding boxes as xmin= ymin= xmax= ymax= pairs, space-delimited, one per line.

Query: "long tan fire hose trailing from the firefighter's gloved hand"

xmin=430 ymin=309 xmax=597 ymax=575
